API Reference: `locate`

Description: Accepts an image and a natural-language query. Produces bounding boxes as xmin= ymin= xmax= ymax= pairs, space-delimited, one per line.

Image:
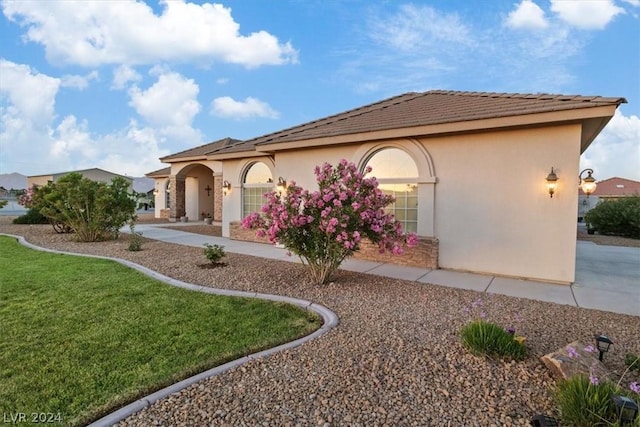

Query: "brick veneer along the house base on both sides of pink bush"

xmin=229 ymin=221 xmax=439 ymax=270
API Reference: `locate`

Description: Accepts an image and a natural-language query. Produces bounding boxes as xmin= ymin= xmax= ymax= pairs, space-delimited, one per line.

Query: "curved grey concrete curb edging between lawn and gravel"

xmin=0 ymin=233 xmax=339 ymax=427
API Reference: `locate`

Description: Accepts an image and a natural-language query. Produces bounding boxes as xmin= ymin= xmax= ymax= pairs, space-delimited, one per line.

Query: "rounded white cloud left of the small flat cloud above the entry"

xmin=129 ymin=72 xmax=200 ymax=127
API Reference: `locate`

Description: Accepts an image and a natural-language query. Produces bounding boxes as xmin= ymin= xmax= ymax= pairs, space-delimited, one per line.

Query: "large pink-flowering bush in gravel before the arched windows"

xmin=242 ymin=159 xmax=417 ymax=284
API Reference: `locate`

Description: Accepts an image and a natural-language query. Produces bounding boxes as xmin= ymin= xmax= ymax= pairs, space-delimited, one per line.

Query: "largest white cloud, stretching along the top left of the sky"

xmin=2 ymin=0 xmax=297 ymax=68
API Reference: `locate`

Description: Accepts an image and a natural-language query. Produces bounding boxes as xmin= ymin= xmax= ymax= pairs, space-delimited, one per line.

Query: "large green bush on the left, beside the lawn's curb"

xmin=28 ymin=172 xmax=136 ymax=242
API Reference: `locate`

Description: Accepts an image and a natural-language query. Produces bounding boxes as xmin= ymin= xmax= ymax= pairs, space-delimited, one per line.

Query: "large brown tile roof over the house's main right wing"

xmin=224 ymin=90 xmax=627 ymax=153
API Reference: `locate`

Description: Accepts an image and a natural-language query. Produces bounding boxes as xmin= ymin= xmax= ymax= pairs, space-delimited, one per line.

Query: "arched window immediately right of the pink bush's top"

xmin=366 ymin=147 xmax=418 ymax=233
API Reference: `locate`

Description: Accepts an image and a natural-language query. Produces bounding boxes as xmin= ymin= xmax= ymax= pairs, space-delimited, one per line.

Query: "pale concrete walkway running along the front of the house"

xmin=132 ymin=223 xmax=640 ymax=316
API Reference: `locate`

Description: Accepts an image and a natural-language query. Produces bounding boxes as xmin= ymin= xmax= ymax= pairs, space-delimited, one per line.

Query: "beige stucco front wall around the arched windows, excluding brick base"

xmin=223 ymin=125 xmax=580 ymax=283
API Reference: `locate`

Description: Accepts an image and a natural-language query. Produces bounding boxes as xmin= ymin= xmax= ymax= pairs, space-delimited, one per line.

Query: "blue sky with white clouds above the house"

xmin=0 ymin=0 xmax=640 ymax=180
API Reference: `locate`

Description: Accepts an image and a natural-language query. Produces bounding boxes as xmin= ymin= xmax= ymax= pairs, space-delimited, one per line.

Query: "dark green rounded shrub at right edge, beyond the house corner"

xmin=584 ymin=195 xmax=640 ymax=239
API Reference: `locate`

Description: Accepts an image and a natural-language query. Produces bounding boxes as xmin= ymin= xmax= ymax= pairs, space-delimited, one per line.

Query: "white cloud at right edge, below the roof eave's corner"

xmin=580 ymin=109 xmax=640 ymax=181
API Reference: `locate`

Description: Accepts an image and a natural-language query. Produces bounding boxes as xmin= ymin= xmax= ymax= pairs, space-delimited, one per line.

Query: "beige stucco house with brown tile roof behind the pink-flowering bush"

xmin=147 ymin=90 xmax=626 ymax=283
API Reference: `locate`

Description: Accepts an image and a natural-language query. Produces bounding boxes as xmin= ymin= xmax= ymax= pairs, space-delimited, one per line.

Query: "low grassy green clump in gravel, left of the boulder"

xmin=461 ymin=320 xmax=527 ymax=360
